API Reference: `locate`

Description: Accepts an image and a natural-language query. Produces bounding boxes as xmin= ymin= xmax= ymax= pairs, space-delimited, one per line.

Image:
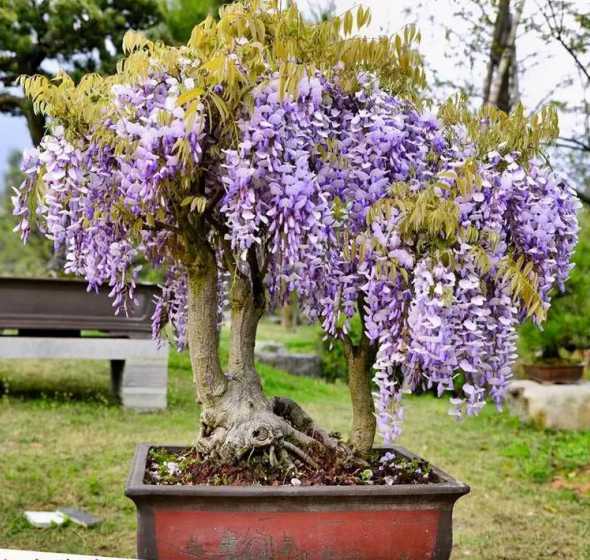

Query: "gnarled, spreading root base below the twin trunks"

xmin=186 ymin=384 xmax=388 ymax=484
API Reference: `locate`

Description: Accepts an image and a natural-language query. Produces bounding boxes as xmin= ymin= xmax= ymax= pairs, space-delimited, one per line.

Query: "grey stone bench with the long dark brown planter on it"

xmin=0 ymin=278 xmax=168 ymax=410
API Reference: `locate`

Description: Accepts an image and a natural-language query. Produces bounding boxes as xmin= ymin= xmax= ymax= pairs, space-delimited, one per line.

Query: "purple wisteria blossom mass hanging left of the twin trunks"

xmin=13 ymin=72 xmax=204 ymax=330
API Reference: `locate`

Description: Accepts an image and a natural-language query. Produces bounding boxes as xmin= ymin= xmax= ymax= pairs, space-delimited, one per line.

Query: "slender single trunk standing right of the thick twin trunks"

xmin=344 ymin=333 xmax=377 ymax=455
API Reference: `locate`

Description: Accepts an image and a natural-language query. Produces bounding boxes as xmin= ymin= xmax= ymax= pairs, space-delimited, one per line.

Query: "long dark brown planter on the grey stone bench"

xmin=0 ymin=278 xmax=159 ymax=337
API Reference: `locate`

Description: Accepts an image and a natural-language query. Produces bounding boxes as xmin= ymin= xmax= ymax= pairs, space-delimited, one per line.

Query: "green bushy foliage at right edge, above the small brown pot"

xmin=520 ymin=209 xmax=590 ymax=360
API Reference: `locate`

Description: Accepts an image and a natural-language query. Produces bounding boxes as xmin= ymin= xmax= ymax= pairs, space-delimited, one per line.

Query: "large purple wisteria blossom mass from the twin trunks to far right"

xmin=217 ymin=72 xmax=577 ymax=440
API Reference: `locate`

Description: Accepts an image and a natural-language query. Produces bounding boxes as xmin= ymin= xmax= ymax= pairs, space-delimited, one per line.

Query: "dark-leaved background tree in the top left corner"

xmin=0 ymin=0 xmax=163 ymax=145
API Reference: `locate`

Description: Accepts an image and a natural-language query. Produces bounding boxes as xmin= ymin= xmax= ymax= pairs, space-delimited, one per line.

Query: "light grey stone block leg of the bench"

xmin=120 ymin=358 xmax=168 ymax=411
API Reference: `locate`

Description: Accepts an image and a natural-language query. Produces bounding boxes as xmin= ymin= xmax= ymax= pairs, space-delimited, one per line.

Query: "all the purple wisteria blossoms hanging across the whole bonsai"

xmin=14 ymin=61 xmax=577 ymax=442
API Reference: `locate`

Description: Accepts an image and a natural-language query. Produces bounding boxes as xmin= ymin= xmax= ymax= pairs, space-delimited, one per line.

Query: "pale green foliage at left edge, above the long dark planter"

xmin=0 ymin=151 xmax=55 ymax=277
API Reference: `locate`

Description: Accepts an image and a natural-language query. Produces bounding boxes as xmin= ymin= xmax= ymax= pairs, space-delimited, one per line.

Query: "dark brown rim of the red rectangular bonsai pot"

xmin=125 ymin=443 xmax=470 ymax=499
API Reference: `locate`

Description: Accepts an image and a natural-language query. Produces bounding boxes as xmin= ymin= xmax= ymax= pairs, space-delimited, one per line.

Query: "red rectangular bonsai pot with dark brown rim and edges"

xmin=125 ymin=444 xmax=469 ymax=560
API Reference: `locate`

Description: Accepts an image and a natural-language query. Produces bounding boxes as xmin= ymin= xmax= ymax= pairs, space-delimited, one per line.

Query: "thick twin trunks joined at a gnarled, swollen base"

xmin=189 ymin=264 xmax=335 ymax=461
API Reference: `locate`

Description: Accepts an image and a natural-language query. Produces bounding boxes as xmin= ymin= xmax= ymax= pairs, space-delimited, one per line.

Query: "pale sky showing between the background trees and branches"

xmin=0 ymin=0 xmax=590 ymax=188
